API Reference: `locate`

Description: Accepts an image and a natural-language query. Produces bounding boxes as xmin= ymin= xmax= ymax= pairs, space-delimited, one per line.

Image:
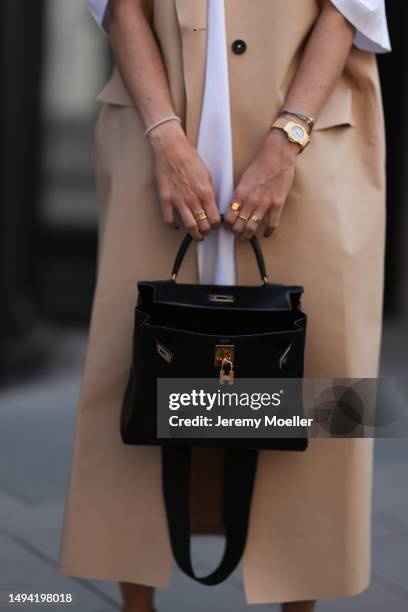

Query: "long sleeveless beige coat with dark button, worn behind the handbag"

xmin=61 ymin=0 xmax=384 ymax=603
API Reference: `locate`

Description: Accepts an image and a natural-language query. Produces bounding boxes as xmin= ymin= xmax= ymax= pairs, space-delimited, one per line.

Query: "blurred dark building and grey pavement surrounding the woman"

xmin=0 ymin=0 xmax=408 ymax=612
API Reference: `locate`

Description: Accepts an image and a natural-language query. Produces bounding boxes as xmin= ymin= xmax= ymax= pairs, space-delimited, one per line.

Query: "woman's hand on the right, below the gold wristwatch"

xmin=224 ymin=128 xmax=300 ymax=240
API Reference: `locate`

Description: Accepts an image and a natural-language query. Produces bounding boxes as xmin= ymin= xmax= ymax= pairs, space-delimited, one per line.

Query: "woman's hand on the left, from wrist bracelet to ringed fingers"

xmin=149 ymin=122 xmax=221 ymax=240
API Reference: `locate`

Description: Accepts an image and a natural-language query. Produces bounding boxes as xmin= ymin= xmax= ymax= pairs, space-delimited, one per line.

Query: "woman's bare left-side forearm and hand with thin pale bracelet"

xmin=109 ymin=0 xmax=221 ymax=240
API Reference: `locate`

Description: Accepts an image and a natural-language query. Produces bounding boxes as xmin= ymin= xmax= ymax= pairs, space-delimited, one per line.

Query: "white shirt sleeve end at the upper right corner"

xmin=331 ymin=0 xmax=391 ymax=53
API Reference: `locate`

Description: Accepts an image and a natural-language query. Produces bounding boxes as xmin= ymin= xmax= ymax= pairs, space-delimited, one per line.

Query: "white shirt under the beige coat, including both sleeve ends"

xmin=87 ymin=0 xmax=391 ymax=285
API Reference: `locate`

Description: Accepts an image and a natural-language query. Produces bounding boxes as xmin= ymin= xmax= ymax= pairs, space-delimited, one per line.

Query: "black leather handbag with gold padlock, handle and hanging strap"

xmin=120 ymin=234 xmax=307 ymax=585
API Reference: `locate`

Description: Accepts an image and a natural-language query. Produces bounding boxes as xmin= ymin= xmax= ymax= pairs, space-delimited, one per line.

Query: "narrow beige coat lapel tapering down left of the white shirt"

xmin=175 ymin=0 xmax=207 ymax=146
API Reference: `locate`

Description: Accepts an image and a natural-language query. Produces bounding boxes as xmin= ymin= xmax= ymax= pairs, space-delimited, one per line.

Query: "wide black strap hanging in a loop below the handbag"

xmin=162 ymin=446 xmax=258 ymax=586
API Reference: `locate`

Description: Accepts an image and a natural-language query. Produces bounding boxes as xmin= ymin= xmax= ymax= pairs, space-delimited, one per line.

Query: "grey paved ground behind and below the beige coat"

xmin=0 ymin=323 xmax=408 ymax=612
